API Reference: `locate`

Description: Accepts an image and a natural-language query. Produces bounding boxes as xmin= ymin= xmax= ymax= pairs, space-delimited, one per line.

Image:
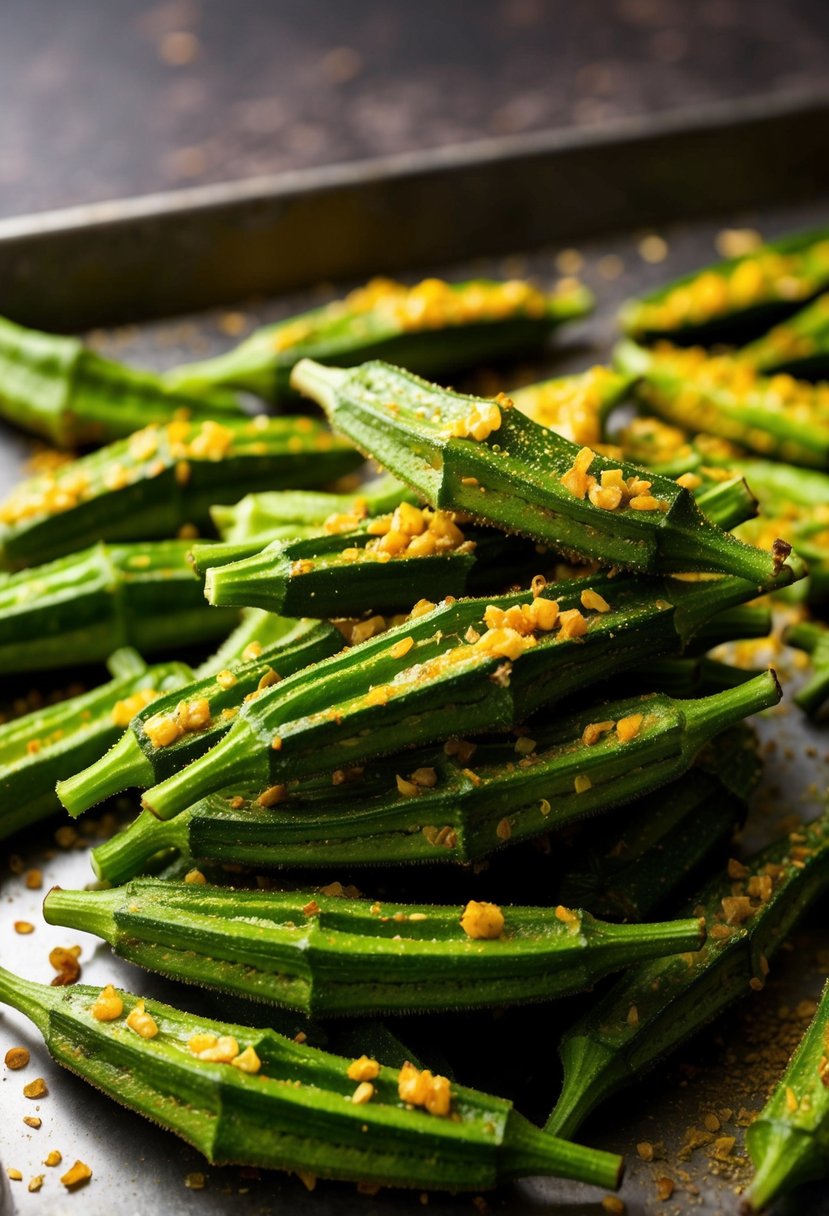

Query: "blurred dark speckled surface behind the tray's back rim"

xmin=0 ymin=0 xmax=829 ymax=215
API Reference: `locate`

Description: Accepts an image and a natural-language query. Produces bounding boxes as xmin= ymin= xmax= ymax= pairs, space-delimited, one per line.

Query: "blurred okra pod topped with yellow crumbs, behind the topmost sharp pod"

xmin=165 ymin=278 xmax=593 ymax=401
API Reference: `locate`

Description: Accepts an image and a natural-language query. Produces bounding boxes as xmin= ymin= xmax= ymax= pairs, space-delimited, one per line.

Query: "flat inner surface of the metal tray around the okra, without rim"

xmin=0 ymin=182 xmax=829 ymax=1216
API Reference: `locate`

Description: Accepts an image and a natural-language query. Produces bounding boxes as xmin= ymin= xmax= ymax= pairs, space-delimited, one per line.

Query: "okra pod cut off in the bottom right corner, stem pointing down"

xmin=744 ymin=985 xmax=829 ymax=1211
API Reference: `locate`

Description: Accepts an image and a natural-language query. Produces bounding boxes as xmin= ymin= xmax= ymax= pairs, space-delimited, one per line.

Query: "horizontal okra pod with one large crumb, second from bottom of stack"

xmin=44 ymin=879 xmax=705 ymax=1017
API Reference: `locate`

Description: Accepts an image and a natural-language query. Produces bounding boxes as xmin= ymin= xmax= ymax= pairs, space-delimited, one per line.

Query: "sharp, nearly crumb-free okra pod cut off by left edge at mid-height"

xmin=0 ymin=541 xmax=238 ymax=674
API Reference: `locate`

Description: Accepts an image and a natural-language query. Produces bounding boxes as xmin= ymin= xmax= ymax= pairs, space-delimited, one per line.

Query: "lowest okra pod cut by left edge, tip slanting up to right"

xmin=0 ymin=651 xmax=192 ymax=839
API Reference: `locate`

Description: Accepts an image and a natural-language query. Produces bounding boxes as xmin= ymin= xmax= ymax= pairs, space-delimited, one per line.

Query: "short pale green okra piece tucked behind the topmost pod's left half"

xmin=210 ymin=477 xmax=417 ymax=544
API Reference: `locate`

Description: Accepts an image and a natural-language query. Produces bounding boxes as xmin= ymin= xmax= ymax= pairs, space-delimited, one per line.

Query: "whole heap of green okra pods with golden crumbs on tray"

xmin=0 ymin=237 xmax=829 ymax=1211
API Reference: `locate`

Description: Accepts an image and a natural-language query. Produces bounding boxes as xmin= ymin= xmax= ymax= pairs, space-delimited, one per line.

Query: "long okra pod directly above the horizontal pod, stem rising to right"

xmin=92 ymin=672 xmax=779 ymax=883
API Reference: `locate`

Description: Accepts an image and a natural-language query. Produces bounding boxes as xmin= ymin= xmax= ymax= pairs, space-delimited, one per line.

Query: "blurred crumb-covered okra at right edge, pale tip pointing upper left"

xmin=616 ymin=342 xmax=829 ymax=471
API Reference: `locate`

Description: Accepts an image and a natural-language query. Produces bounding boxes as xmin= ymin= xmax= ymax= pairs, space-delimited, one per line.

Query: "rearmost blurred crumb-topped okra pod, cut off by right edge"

xmin=620 ymin=229 xmax=829 ymax=344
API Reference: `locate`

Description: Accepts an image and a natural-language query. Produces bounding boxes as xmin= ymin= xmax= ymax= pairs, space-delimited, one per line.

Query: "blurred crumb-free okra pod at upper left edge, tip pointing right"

xmin=0 ymin=317 xmax=239 ymax=447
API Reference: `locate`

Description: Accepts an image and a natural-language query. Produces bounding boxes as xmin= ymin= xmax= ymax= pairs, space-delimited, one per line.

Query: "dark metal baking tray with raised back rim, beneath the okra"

xmin=0 ymin=97 xmax=829 ymax=1216
